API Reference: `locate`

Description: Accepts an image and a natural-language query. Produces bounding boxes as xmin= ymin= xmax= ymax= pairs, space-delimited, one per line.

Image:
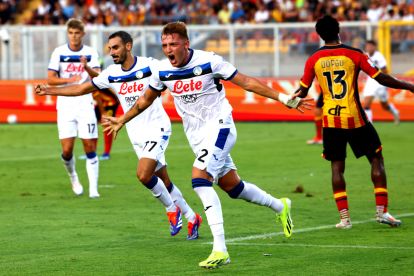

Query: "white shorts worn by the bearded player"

xmin=130 ymin=130 xmax=171 ymax=171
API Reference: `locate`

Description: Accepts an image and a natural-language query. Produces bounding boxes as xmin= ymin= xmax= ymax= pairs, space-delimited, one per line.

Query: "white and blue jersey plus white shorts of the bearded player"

xmin=92 ymin=57 xmax=171 ymax=168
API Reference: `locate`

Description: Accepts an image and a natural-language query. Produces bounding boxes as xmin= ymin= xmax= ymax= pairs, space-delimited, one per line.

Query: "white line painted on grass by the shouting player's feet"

xmin=206 ymin=213 xmax=414 ymax=246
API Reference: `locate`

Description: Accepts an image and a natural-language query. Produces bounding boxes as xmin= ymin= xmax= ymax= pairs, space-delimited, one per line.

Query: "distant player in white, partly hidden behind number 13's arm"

xmin=362 ymin=40 xmax=400 ymax=124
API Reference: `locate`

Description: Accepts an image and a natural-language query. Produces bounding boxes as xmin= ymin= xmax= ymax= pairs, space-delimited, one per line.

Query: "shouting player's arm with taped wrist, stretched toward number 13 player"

xmin=231 ymin=73 xmax=313 ymax=113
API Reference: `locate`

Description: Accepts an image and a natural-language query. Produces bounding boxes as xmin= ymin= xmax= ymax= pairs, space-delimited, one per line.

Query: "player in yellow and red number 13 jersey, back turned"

xmin=295 ymin=15 xmax=414 ymax=229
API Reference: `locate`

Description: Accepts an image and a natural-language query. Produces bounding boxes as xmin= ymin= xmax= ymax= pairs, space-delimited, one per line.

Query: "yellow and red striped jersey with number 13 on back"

xmin=300 ymin=44 xmax=381 ymax=129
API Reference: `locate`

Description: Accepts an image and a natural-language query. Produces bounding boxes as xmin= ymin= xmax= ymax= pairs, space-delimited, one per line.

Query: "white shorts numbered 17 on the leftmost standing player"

xmin=57 ymin=108 xmax=98 ymax=139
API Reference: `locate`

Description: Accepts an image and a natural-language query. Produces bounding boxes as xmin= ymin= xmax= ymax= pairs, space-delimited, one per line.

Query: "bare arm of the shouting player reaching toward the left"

xmin=102 ymin=88 xmax=161 ymax=138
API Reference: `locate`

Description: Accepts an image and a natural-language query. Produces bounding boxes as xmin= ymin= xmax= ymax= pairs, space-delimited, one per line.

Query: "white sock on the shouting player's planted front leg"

xmin=194 ymin=186 xmax=227 ymax=252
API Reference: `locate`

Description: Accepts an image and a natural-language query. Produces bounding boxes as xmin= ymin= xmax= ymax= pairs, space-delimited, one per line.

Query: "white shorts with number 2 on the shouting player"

xmin=187 ymin=114 xmax=237 ymax=182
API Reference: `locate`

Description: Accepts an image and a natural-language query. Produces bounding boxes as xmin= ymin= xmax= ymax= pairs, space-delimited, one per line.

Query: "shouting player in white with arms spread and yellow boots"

xmin=102 ymin=22 xmax=312 ymax=268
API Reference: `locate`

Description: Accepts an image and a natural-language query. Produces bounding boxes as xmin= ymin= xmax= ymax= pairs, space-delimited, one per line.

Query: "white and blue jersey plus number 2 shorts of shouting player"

xmin=150 ymin=49 xmax=237 ymax=178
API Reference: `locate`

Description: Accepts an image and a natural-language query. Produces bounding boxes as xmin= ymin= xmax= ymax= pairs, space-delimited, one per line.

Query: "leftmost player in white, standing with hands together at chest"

xmin=47 ymin=19 xmax=100 ymax=198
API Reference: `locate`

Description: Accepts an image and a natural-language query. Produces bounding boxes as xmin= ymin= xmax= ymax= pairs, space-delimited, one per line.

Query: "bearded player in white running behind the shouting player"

xmin=36 ymin=31 xmax=202 ymax=240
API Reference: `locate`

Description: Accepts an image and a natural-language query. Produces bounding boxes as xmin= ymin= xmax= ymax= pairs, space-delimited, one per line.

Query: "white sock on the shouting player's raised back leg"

xmin=238 ymin=181 xmax=284 ymax=213
